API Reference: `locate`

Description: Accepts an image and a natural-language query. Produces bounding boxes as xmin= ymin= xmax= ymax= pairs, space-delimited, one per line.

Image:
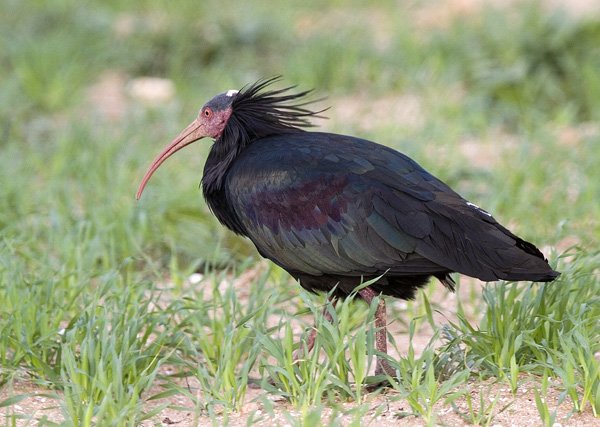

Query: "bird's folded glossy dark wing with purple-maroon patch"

xmin=226 ymin=132 xmax=547 ymax=280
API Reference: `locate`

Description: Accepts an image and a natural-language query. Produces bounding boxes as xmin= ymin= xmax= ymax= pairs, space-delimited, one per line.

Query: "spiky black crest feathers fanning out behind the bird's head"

xmin=222 ymin=76 xmax=325 ymax=147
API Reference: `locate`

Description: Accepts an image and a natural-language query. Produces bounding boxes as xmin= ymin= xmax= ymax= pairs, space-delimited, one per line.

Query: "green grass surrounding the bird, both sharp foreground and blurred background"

xmin=0 ymin=0 xmax=600 ymax=426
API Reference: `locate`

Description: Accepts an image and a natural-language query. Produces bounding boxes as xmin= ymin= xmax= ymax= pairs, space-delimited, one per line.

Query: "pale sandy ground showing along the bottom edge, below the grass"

xmin=0 ymin=330 xmax=600 ymax=426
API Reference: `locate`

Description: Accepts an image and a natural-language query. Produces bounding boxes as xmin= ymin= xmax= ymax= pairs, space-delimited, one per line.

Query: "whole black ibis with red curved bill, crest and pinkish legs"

xmin=137 ymin=78 xmax=560 ymax=376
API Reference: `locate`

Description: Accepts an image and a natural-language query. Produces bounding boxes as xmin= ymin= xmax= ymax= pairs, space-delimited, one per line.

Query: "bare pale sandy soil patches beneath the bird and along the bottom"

xmin=0 ymin=276 xmax=600 ymax=427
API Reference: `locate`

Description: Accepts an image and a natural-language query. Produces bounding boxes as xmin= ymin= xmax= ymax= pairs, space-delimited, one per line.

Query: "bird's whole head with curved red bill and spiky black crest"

xmin=136 ymin=77 xmax=323 ymax=199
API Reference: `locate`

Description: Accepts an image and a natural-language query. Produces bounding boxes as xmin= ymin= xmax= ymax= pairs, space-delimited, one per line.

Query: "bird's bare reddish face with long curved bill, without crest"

xmin=135 ymin=89 xmax=239 ymax=199
